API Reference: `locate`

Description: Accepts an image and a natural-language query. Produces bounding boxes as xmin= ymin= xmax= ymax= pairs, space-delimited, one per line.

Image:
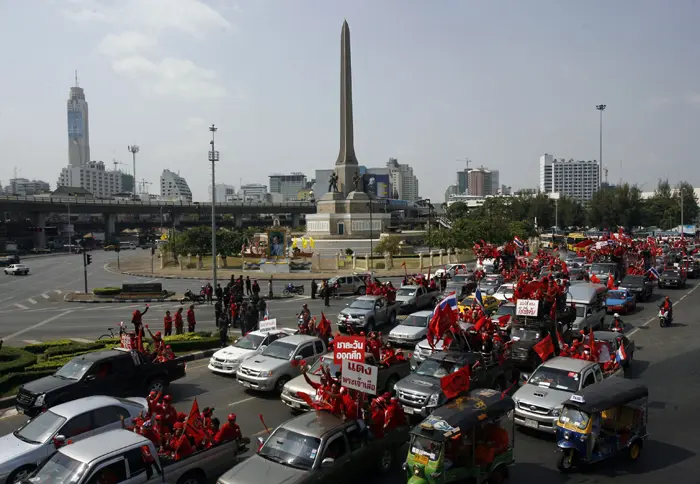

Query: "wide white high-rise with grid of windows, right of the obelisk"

xmin=540 ymin=153 xmax=600 ymax=202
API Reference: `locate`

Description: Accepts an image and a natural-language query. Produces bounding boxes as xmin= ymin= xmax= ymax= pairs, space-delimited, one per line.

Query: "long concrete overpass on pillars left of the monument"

xmin=0 ymin=195 xmax=316 ymax=247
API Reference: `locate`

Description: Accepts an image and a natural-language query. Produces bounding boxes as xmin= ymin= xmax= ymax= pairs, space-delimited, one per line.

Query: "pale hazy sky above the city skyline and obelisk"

xmin=0 ymin=0 xmax=700 ymax=200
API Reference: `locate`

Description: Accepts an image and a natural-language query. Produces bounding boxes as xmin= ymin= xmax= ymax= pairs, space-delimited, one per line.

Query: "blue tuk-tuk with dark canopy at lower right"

xmin=556 ymin=377 xmax=649 ymax=472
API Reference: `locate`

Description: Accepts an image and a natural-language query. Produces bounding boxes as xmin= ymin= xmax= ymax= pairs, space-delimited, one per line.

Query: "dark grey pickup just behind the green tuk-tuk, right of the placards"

xmin=394 ymin=351 xmax=515 ymax=418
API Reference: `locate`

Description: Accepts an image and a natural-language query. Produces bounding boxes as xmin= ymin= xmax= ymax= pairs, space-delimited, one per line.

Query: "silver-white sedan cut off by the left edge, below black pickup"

xmin=0 ymin=396 xmax=148 ymax=484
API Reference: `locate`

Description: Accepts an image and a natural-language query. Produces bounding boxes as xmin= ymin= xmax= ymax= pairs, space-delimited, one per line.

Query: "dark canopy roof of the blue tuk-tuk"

xmin=566 ymin=377 xmax=649 ymax=413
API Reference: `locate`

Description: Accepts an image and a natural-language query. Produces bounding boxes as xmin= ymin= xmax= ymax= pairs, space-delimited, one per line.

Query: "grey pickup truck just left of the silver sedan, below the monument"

xmin=337 ymin=296 xmax=401 ymax=333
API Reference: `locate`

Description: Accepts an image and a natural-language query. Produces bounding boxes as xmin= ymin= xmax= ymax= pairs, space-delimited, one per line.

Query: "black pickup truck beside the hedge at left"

xmin=15 ymin=349 xmax=185 ymax=417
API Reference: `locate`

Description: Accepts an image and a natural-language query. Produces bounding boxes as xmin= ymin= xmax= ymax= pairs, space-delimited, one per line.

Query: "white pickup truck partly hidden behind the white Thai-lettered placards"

xmin=282 ymin=353 xmax=411 ymax=410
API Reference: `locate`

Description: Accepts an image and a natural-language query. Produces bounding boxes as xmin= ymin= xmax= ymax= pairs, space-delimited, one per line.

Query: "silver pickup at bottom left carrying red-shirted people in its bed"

xmin=26 ymin=430 xmax=243 ymax=484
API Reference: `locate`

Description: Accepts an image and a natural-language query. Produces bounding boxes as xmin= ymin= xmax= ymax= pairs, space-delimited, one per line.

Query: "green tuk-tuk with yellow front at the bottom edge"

xmin=403 ymin=388 xmax=515 ymax=484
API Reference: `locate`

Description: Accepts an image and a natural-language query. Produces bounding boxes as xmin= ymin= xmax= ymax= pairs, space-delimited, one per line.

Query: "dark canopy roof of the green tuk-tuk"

xmin=411 ymin=388 xmax=515 ymax=442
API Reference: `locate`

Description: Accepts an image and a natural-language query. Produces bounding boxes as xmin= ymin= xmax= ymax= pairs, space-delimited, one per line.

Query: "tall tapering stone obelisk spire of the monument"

xmin=335 ymin=20 xmax=359 ymax=195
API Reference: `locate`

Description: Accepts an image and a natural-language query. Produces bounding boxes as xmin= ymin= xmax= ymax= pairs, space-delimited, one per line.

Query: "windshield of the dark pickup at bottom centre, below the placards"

xmin=258 ymin=428 xmax=321 ymax=471
